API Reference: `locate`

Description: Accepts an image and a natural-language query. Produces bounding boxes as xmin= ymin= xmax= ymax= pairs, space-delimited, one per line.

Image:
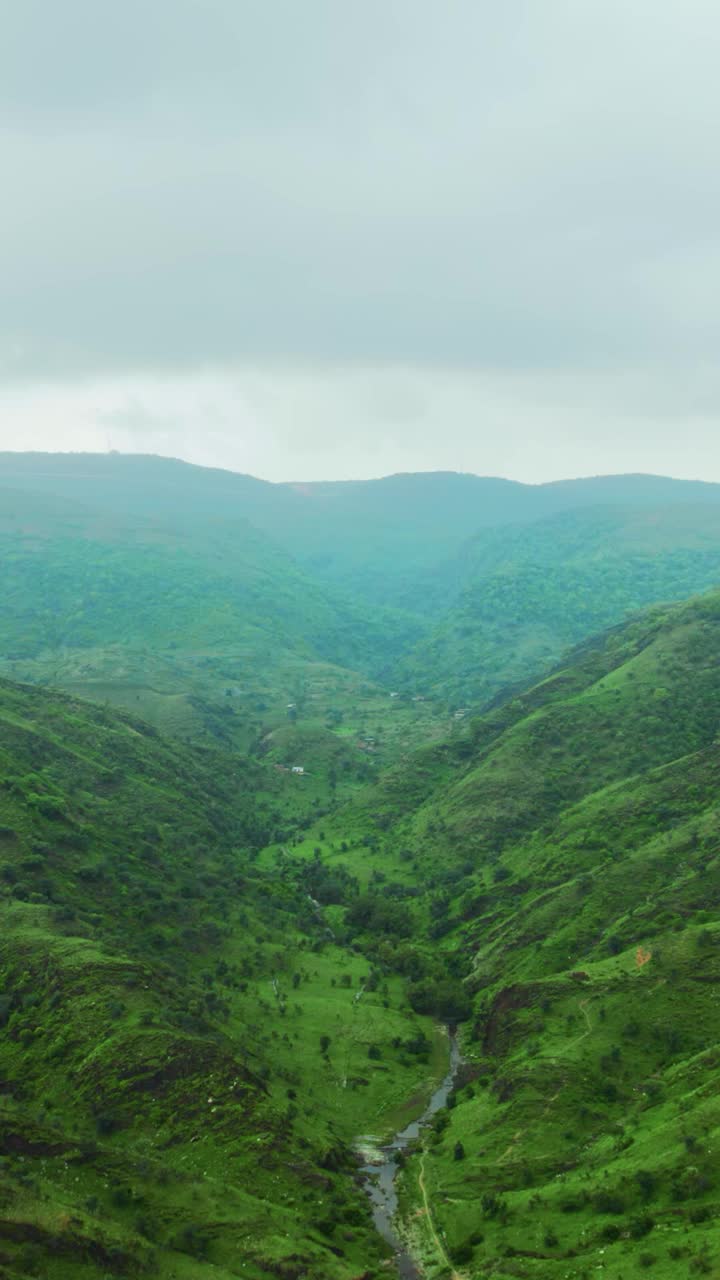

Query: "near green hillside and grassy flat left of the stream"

xmin=0 ymin=682 xmax=453 ymax=1280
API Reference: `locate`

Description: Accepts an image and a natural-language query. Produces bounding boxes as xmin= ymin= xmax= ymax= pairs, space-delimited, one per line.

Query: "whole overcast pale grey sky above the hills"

xmin=0 ymin=0 xmax=720 ymax=480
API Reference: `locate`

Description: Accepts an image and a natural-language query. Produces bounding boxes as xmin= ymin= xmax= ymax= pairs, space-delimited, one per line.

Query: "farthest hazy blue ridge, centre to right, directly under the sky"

xmin=279 ymin=472 xmax=720 ymax=617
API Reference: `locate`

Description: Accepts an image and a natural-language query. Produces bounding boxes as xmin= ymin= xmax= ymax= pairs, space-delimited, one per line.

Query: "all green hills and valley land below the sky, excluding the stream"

xmin=0 ymin=454 xmax=720 ymax=1280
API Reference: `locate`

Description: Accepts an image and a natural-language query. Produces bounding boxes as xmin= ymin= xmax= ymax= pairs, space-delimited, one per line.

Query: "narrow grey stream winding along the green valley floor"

xmin=357 ymin=1036 xmax=462 ymax=1280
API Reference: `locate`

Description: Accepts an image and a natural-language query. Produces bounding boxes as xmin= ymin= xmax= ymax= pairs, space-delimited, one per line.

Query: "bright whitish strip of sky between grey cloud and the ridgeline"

xmin=0 ymin=364 xmax=720 ymax=481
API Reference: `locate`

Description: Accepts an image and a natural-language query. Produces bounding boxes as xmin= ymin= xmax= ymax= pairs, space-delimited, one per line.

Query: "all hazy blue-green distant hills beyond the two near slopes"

xmin=0 ymin=453 xmax=720 ymax=742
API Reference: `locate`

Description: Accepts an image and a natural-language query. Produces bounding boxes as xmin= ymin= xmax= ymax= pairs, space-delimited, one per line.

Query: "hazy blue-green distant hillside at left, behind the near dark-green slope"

xmin=0 ymin=468 xmax=443 ymax=791
